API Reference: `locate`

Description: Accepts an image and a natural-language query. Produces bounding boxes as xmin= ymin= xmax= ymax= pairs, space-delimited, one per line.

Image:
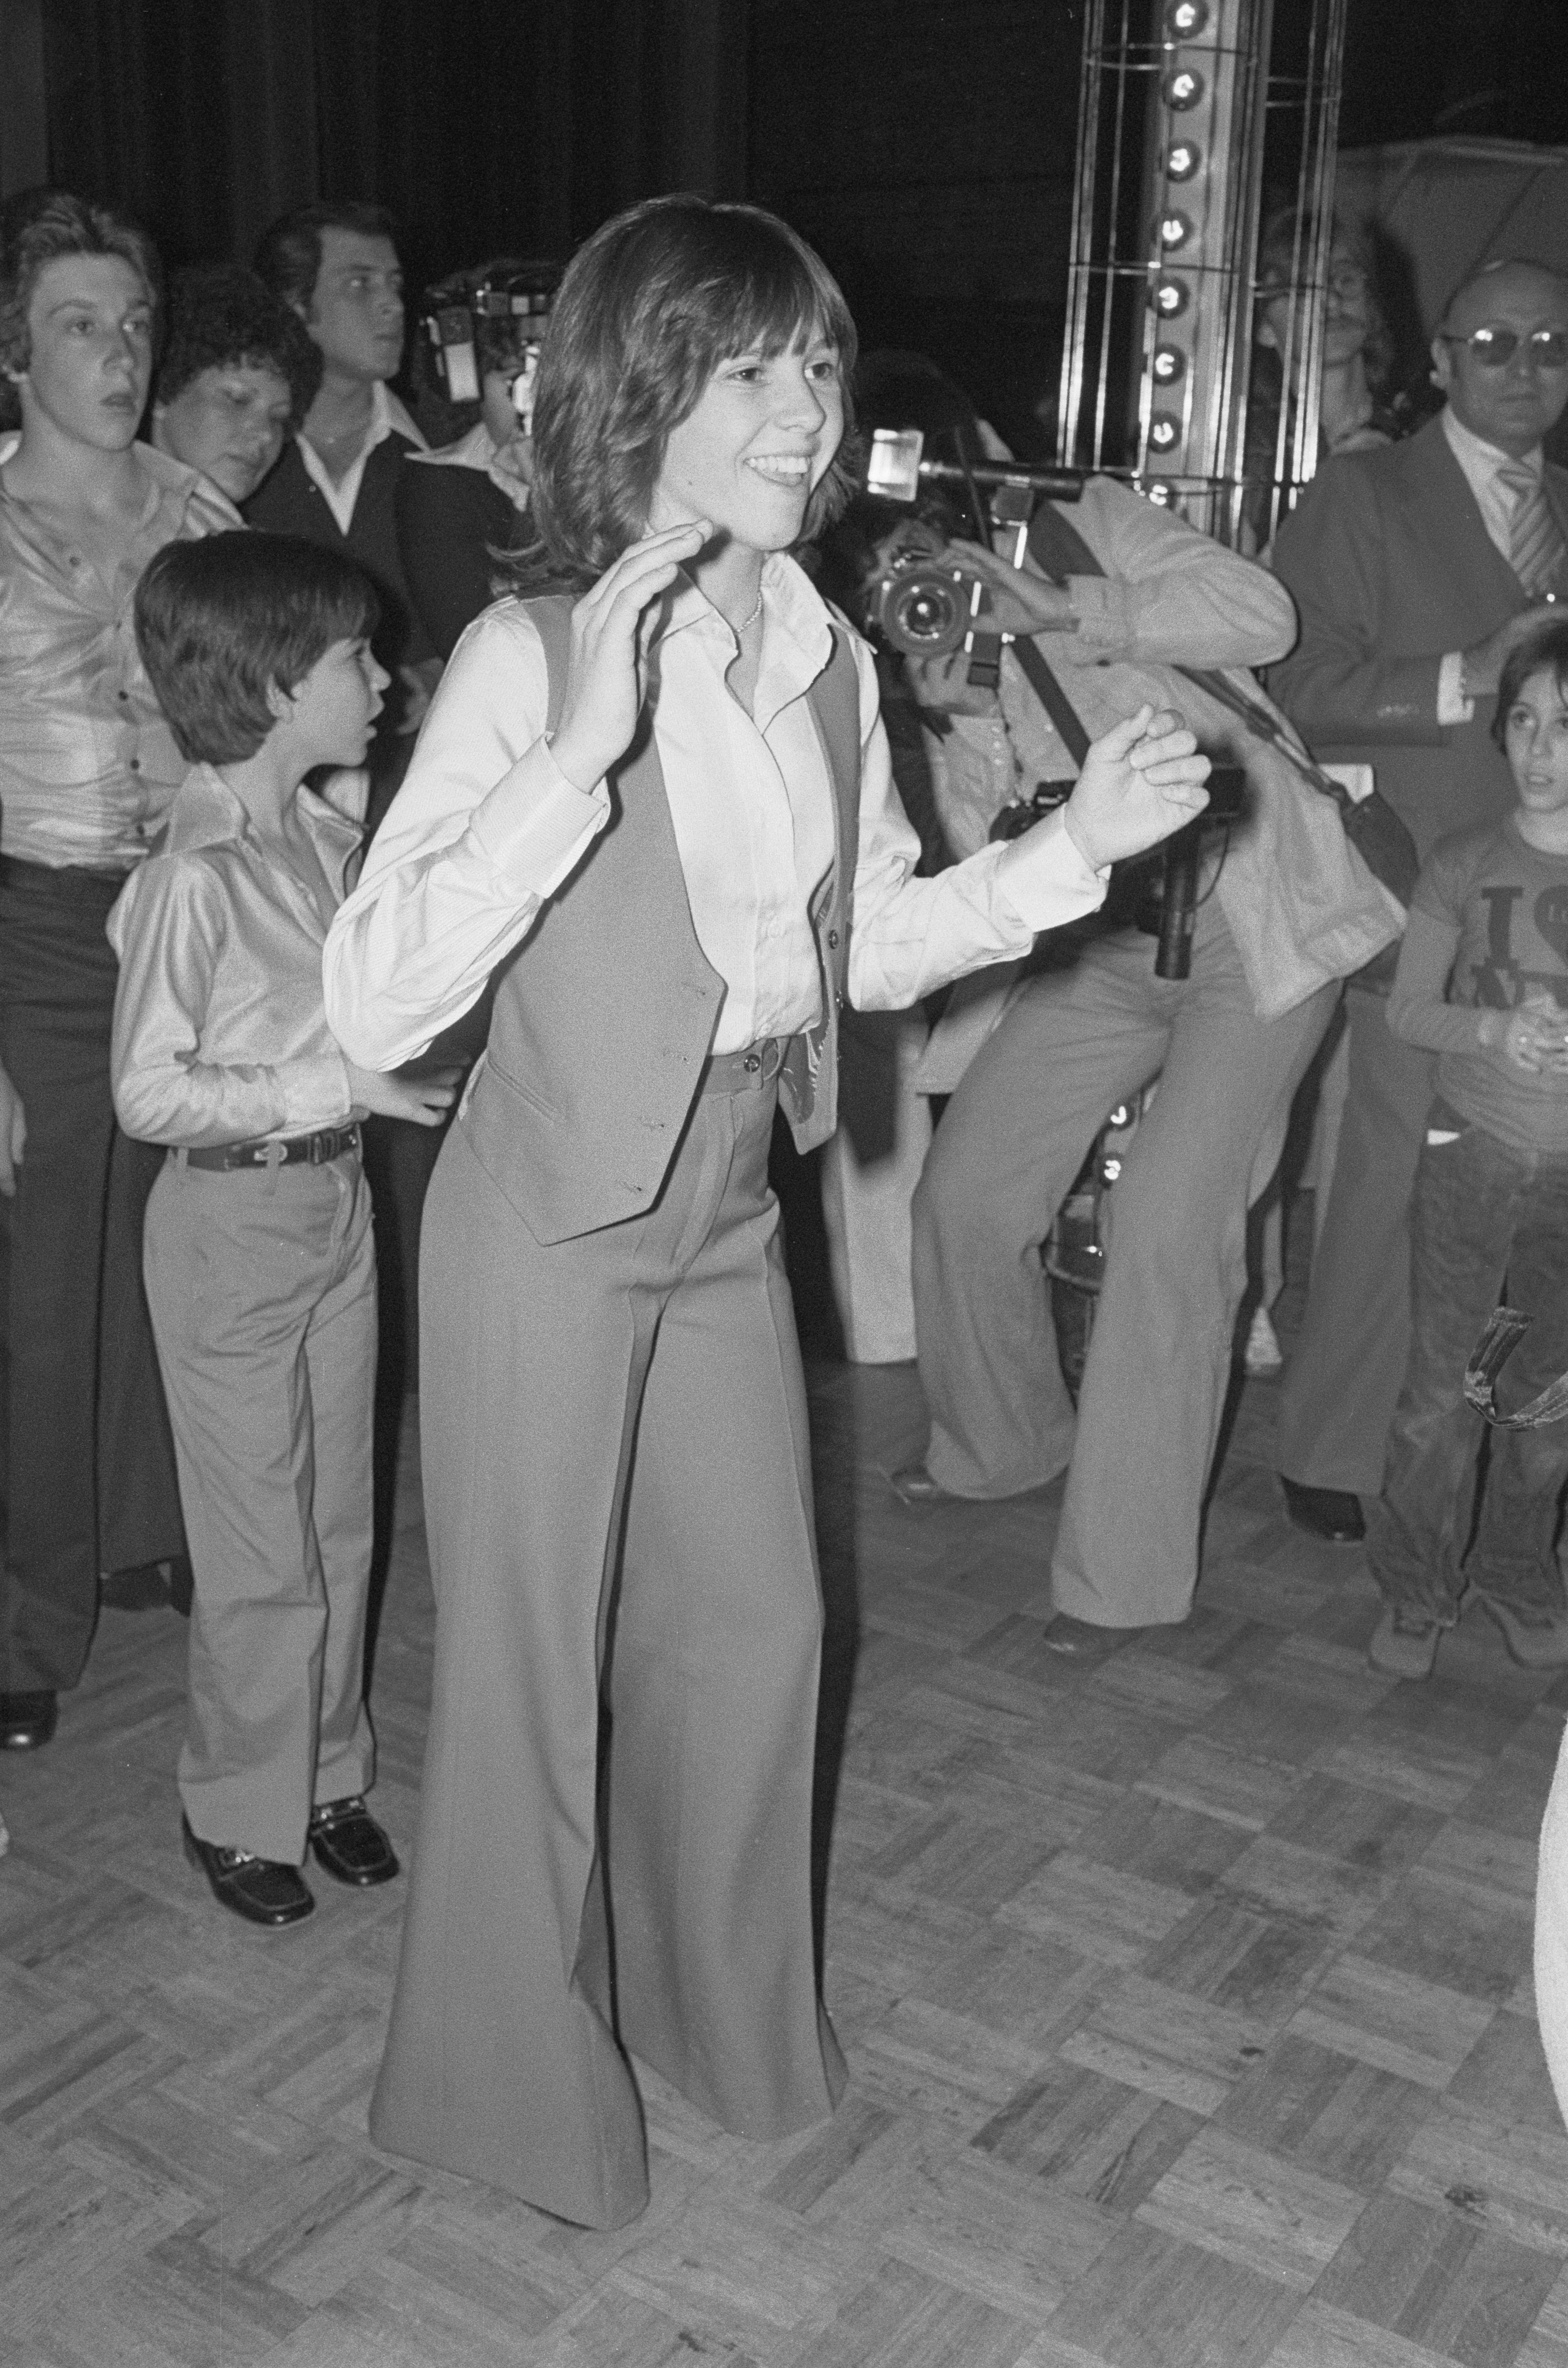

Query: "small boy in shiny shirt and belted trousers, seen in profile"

xmin=109 ymin=533 xmax=452 ymax=1925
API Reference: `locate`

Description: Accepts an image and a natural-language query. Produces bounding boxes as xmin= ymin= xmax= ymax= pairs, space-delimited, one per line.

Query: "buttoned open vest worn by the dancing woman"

xmin=459 ymin=594 xmax=860 ymax=1241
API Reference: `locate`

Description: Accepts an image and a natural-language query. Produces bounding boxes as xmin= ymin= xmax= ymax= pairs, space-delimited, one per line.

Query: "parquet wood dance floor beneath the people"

xmin=0 ymin=1212 xmax=1568 ymax=2368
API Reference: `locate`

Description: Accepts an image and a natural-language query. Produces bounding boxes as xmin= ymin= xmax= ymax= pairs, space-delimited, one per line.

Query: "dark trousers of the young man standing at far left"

xmin=0 ymin=862 xmax=185 ymax=1693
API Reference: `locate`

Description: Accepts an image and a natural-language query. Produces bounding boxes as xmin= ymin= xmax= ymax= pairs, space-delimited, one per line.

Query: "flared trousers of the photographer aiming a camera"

xmin=914 ymin=900 xmax=1336 ymax=1627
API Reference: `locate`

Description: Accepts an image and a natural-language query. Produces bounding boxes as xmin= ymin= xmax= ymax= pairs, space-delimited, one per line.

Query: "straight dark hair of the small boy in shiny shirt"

xmin=135 ymin=531 xmax=381 ymax=765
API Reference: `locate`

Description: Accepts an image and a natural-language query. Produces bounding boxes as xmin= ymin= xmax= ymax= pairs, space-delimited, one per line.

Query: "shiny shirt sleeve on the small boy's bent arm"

xmin=109 ymin=857 xmax=353 ymax=1151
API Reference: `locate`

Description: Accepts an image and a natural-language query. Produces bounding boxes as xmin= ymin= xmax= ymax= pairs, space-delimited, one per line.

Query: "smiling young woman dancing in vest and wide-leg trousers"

xmin=327 ymin=197 xmax=1208 ymax=2228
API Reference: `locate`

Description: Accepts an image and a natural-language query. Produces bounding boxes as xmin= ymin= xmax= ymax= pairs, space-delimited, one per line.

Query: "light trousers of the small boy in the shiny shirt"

xmin=147 ymin=1153 xmax=376 ymax=1866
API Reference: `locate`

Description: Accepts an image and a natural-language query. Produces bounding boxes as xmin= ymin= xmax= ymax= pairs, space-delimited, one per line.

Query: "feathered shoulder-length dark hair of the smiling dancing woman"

xmin=514 ymin=197 xmax=855 ymax=590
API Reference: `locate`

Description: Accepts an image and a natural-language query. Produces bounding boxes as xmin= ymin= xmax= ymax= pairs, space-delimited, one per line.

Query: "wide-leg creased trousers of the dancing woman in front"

xmin=369 ymin=1087 xmax=843 ymax=2228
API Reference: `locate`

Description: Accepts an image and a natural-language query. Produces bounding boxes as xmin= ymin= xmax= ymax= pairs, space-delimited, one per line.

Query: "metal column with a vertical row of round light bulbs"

xmin=1059 ymin=0 xmax=1345 ymax=542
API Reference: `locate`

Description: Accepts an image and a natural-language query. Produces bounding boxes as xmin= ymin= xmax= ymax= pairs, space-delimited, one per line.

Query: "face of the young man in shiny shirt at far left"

xmin=14 ymin=256 xmax=154 ymax=453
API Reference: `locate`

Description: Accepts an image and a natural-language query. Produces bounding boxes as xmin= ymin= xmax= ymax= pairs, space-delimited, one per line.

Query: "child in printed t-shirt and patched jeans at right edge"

xmin=1369 ymin=623 xmax=1568 ymax=1677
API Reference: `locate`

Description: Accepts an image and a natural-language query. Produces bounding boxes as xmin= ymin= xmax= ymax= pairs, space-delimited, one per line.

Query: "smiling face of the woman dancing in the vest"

xmin=649 ymin=331 xmax=843 ymax=552
